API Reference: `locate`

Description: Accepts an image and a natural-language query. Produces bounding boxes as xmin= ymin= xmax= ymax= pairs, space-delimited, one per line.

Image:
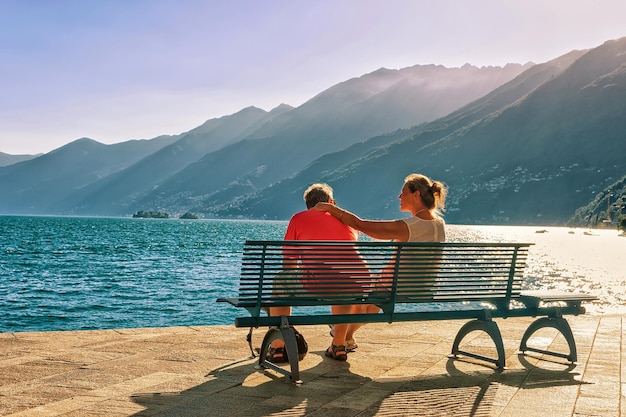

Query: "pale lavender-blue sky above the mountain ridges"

xmin=0 ymin=0 xmax=626 ymax=155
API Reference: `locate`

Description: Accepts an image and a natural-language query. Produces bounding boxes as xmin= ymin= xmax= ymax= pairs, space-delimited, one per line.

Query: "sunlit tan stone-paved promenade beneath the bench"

xmin=0 ymin=316 xmax=626 ymax=417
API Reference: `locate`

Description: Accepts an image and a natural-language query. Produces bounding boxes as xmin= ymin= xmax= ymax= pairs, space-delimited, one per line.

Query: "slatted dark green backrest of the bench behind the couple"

xmin=239 ymin=241 xmax=531 ymax=310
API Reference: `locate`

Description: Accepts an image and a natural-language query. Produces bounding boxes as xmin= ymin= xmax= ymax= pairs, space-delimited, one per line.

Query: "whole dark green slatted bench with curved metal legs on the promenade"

xmin=217 ymin=240 xmax=596 ymax=384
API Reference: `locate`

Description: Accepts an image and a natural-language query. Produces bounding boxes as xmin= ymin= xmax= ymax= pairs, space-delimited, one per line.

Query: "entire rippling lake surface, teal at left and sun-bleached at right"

xmin=0 ymin=216 xmax=626 ymax=332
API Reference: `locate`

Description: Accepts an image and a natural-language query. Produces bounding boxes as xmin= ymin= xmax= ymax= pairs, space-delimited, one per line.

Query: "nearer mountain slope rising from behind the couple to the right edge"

xmin=225 ymin=38 xmax=626 ymax=224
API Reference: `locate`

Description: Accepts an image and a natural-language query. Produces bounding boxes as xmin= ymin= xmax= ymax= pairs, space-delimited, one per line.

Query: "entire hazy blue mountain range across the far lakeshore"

xmin=0 ymin=38 xmax=626 ymax=225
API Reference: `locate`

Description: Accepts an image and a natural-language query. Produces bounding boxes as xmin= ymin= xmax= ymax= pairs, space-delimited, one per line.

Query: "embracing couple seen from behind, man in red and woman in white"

xmin=268 ymin=174 xmax=447 ymax=363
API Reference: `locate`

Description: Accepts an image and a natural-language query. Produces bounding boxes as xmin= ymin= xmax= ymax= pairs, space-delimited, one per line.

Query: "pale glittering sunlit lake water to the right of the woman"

xmin=447 ymin=225 xmax=626 ymax=314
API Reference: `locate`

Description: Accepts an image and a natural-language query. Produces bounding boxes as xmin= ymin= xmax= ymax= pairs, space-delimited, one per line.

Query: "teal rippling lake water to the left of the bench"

xmin=0 ymin=216 xmax=287 ymax=332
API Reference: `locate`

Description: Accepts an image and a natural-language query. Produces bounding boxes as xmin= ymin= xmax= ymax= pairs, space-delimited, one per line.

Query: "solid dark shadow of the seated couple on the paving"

xmin=132 ymin=351 xmax=371 ymax=417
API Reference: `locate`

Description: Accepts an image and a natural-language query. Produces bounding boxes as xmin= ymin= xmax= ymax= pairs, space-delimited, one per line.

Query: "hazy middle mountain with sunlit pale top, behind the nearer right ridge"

xmin=128 ymin=64 xmax=532 ymax=216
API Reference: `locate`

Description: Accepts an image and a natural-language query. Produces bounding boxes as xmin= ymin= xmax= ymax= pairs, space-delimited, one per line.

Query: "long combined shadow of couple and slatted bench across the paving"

xmin=132 ymin=344 xmax=584 ymax=417
